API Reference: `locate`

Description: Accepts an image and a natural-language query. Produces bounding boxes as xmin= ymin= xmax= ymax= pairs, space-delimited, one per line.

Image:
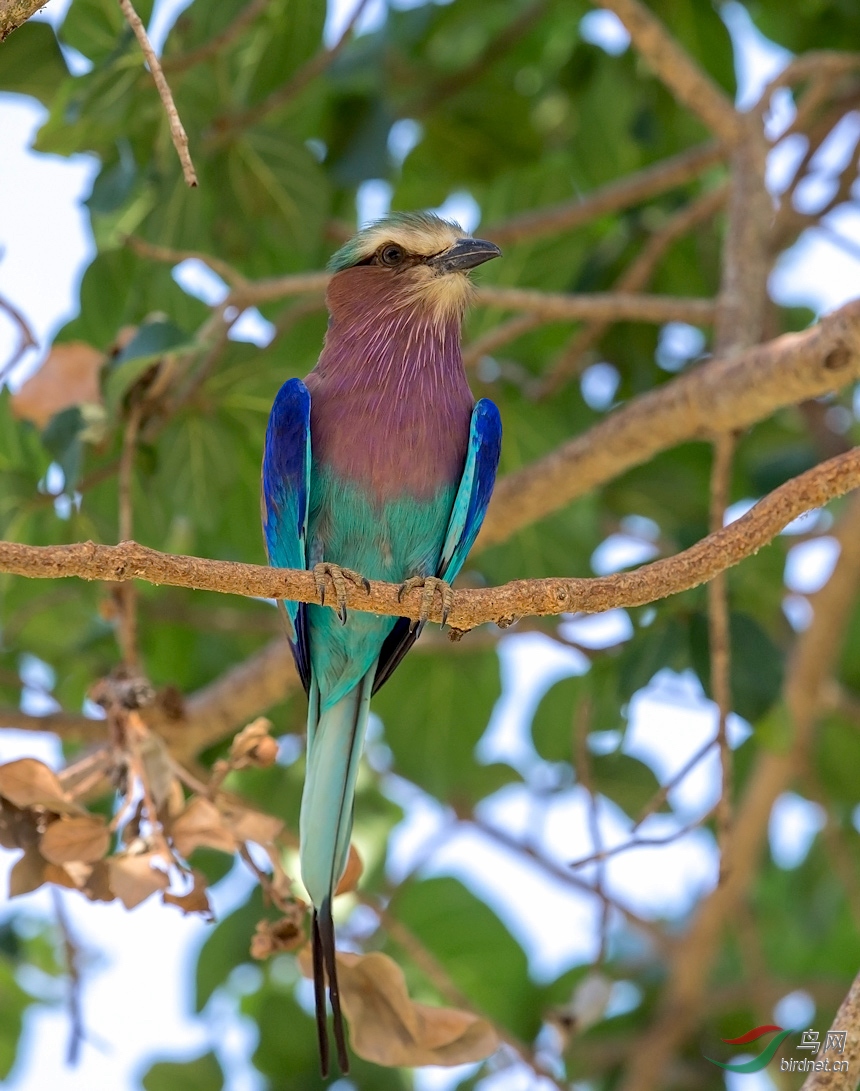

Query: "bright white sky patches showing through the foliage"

xmin=0 ymin=0 xmax=860 ymax=1091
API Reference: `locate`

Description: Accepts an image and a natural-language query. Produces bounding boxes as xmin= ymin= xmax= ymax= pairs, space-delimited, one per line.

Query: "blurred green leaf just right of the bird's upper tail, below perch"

xmin=373 ymin=647 xmax=517 ymax=807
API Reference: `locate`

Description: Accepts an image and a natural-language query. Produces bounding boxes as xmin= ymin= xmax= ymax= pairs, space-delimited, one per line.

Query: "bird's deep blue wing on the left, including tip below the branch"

xmin=262 ymin=379 xmax=311 ymax=692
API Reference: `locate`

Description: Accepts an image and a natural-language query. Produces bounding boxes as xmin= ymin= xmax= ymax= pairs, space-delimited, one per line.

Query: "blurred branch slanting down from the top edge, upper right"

xmin=599 ymin=0 xmax=740 ymax=144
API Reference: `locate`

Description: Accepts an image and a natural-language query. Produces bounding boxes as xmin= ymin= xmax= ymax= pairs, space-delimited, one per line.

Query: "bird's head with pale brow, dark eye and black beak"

xmin=329 ymin=212 xmax=501 ymax=322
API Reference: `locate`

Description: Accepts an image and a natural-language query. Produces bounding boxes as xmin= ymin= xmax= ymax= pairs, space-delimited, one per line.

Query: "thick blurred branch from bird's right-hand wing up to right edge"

xmin=476 ymin=300 xmax=860 ymax=549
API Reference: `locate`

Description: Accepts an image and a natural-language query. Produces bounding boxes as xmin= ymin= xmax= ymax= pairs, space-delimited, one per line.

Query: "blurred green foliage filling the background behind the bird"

xmin=0 ymin=0 xmax=860 ymax=1091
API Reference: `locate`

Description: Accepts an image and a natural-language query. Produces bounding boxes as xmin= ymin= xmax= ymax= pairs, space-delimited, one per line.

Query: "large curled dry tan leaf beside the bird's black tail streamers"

xmin=299 ymin=946 xmax=500 ymax=1068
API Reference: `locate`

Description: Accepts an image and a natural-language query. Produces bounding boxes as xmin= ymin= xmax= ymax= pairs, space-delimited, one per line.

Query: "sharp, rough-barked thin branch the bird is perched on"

xmin=0 ymin=447 xmax=860 ymax=632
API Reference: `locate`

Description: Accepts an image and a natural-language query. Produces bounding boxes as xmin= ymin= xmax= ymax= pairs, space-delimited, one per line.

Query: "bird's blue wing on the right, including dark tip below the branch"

xmin=373 ymin=398 xmax=502 ymax=693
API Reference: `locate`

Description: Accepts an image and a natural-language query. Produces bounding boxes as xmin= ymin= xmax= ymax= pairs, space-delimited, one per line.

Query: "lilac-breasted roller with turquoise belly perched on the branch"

xmin=262 ymin=212 xmax=502 ymax=1076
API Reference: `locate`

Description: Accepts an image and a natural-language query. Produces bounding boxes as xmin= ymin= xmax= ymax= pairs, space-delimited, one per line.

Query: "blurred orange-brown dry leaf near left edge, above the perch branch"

xmin=12 ymin=341 xmax=105 ymax=428
